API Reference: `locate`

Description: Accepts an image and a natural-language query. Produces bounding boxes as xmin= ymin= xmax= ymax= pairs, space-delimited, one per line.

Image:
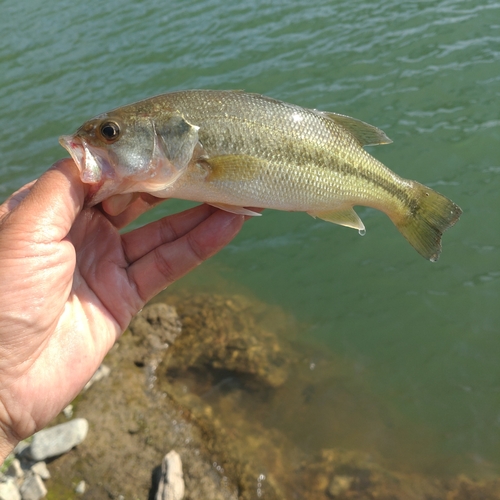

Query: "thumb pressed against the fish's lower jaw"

xmin=2 ymin=158 xmax=86 ymax=243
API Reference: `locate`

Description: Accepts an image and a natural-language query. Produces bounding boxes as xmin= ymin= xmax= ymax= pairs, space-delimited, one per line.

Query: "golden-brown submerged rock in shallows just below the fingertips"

xmin=163 ymin=294 xmax=294 ymax=388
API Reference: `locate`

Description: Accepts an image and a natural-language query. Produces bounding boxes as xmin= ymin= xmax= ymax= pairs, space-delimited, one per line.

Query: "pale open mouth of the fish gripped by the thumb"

xmin=59 ymin=135 xmax=114 ymax=207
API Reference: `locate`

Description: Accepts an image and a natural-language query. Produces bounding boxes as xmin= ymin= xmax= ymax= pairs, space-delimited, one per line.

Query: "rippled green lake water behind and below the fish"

xmin=0 ymin=0 xmax=500 ymax=473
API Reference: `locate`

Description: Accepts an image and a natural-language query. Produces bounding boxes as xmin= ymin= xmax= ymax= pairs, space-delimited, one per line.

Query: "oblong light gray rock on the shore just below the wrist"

xmin=29 ymin=418 xmax=89 ymax=461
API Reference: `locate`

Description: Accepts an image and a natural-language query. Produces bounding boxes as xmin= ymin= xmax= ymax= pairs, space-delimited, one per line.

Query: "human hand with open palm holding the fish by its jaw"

xmin=0 ymin=159 xmax=244 ymax=463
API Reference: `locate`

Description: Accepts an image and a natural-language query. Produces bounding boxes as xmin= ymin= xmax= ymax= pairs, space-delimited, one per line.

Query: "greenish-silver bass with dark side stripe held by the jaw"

xmin=59 ymin=90 xmax=462 ymax=262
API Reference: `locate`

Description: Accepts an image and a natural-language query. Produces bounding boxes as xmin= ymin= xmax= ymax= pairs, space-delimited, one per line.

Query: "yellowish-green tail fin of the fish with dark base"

xmin=389 ymin=182 xmax=462 ymax=262
